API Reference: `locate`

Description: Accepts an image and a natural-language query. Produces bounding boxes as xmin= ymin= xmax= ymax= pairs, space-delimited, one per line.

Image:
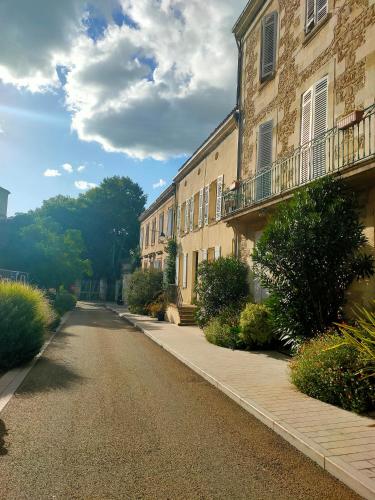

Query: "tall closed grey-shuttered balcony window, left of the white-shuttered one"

xmin=256 ymin=120 xmax=273 ymax=200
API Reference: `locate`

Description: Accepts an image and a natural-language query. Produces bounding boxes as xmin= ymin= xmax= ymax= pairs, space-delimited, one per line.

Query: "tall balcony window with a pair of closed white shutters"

xmin=300 ymin=77 xmax=328 ymax=182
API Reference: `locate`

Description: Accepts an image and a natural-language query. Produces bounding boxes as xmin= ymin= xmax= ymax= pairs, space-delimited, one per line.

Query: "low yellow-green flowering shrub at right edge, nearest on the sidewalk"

xmin=290 ymin=333 xmax=375 ymax=413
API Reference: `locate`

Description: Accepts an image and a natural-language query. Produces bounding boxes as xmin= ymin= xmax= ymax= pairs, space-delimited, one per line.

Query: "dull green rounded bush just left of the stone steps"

xmin=127 ymin=269 xmax=163 ymax=314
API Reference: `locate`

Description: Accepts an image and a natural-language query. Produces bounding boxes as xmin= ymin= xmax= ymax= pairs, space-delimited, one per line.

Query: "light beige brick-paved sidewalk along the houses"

xmin=107 ymin=305 xmax=375 ymax=500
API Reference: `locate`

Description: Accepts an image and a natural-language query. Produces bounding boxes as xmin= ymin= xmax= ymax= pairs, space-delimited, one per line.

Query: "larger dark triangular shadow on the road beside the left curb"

xmin=17 ymin=357 xmax=84 ymax=395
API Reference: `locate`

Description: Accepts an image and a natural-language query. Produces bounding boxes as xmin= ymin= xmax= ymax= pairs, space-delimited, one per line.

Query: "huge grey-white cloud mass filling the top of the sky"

xmin=0 ymin=0 xmax=246 ymax=159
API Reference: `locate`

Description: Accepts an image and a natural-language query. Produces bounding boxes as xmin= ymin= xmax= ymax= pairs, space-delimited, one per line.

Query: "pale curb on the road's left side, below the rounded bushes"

xmin=0 ymin=311 xmax=72 ymax=414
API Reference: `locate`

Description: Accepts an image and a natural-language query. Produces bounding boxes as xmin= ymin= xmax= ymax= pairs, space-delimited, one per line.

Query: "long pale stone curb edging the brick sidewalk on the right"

xmin=105 ymin=305 xmax=375 ymax=500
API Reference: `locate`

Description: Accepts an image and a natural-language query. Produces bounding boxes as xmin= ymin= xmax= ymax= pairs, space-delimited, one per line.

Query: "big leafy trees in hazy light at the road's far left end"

xmin=0 ymin=176 xmax=146 ymax=288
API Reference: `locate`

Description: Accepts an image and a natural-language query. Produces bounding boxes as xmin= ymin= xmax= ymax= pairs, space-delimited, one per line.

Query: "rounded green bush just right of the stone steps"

xmin=195 ymin=257 xmax=249 ymax=327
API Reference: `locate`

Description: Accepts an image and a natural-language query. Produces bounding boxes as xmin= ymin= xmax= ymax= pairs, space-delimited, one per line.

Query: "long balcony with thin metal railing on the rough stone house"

xmin=222 ymin=104 xmax=375 ymax=218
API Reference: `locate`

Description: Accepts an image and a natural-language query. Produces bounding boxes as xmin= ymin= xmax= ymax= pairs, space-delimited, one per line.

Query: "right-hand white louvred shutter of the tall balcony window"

xmin=312 ymin=78 xmax=328 ymax=177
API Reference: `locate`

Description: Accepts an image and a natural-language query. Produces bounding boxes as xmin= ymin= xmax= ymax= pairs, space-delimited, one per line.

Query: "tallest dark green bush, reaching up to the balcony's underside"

xmin=253 ymin=177 xmax=374 ymax=344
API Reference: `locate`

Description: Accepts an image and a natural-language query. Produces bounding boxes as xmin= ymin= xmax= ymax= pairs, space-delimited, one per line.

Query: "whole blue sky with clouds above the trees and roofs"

xmin=0 ymin=0 xmax=246 ymax=215
